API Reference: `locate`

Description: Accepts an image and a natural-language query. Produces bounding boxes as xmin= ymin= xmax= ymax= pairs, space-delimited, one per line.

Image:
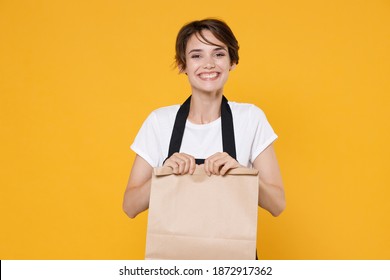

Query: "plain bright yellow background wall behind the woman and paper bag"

xmin=0 ymin=0 xmax=390 ymax=259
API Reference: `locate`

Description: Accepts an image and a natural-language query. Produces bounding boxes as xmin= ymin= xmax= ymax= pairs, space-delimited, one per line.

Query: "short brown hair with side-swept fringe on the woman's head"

xmin=175 ymin=18 xmax=239 ymax=70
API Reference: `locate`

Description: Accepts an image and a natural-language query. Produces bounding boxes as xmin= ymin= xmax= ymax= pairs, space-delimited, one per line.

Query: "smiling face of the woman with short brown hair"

xmin=183 ymin=30 xmax=235 ymax=94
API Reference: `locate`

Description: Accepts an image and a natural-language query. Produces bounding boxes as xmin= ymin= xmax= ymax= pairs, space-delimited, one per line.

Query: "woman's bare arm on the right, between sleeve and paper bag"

xmin=253 ymin=144 xmax=286 ymax=217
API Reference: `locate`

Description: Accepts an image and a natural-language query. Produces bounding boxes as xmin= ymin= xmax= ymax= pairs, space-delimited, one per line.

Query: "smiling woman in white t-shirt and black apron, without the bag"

xmin=123 ymin=19 xmax=285 ymax=218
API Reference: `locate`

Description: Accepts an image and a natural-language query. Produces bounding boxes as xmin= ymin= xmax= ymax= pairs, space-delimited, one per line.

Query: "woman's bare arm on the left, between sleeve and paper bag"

xmin=123 ymin=155 xmax=153 ymax=218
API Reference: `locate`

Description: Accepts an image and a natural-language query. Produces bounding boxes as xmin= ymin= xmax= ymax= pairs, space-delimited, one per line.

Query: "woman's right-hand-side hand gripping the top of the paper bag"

xmin=204 ymin=152 xmax=241 ymax=176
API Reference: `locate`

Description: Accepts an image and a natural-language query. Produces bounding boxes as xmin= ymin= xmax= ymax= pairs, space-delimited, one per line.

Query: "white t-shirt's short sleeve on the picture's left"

xmin=131 ymin=112 xmax=161 ymax=167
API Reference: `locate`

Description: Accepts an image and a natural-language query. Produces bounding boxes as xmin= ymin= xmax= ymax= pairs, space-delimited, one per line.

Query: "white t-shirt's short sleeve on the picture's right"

xmin=251 ymin=106 xmax=278 ymax=162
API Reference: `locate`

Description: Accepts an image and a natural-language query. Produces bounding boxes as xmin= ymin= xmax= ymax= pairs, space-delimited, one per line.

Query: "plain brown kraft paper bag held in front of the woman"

xmin=145 ymin=166 xmax=258 ymax=260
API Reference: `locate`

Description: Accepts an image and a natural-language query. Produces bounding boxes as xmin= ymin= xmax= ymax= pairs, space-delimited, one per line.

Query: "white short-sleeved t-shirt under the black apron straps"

xmin=131 ymin=102 xmax=277 ymax=167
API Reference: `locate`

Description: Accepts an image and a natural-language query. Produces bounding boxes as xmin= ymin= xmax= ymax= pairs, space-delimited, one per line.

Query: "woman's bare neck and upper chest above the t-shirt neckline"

xmin=188 ymin=92 xmax=222 ymax=124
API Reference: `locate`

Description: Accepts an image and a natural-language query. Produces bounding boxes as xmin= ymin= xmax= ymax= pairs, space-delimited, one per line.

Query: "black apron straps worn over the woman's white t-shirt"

xmin=164 ymin=96 xmax=237 ymax=164
